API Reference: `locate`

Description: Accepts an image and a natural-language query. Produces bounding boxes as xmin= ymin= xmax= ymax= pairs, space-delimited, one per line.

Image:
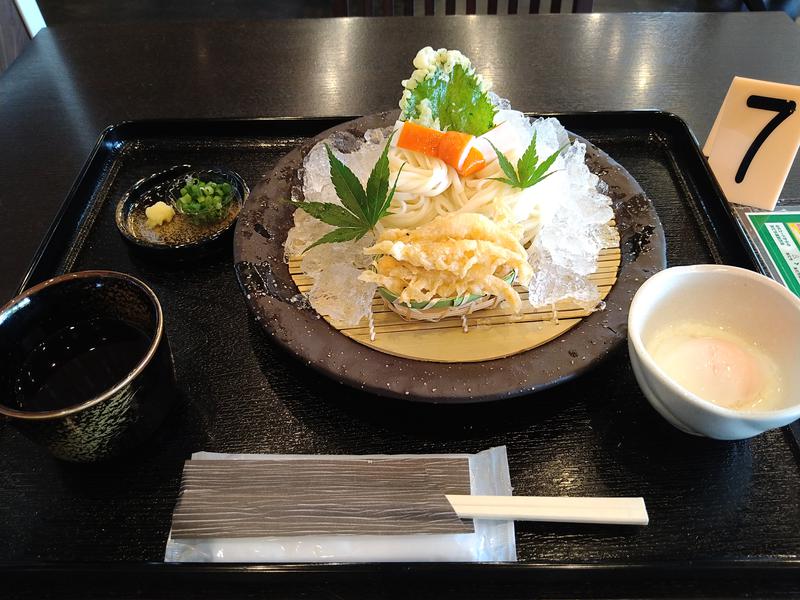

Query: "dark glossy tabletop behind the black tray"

xmin=0 ymin=13 xmax=800 ymax=597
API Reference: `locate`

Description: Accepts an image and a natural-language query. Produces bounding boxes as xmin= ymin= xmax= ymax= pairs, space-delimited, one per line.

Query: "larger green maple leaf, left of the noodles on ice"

xmin=292 ymin=137 xmax=403 ymax=252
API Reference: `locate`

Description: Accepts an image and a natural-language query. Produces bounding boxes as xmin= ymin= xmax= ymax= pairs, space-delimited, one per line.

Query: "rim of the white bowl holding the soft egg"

xmin=628 ymin=264 xmax=800 ymax=423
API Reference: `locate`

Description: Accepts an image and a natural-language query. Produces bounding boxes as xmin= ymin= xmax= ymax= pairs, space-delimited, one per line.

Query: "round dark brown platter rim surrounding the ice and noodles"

xmin=234 ymin=111 xmax=666 ymax=403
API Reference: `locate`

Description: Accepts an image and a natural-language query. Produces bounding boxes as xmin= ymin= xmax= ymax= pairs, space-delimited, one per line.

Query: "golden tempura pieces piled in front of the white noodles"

xmin=359 ymin=213 xmax=532 ymax=312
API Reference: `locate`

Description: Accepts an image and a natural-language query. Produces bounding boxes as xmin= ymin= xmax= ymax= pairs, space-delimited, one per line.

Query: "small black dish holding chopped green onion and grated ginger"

xmin=115 ymin=165 xmax=250 ymax=260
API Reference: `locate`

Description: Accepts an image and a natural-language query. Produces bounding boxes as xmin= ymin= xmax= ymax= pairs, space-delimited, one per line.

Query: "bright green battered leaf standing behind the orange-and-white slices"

xmin=401 ymin=64 xmax=497 ymax=136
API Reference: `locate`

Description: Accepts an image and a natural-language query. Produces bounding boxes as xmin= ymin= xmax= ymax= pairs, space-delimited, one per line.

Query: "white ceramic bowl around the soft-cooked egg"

xmin=628 ymin=265 xmax=800 ymax=440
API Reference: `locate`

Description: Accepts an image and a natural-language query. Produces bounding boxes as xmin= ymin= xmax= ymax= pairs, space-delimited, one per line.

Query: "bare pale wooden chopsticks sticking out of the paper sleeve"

xmin=446 ymin=494 xmax=650 ymax=525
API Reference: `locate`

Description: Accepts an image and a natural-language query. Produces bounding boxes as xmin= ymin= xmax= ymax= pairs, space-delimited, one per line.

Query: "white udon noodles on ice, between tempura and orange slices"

xmin=380 ymin=148 xmax=539 ymax=245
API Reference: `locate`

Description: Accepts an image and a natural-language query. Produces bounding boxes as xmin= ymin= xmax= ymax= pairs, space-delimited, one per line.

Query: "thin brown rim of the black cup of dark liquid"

xmin=0 ymin=269 xmax=164 ymax=421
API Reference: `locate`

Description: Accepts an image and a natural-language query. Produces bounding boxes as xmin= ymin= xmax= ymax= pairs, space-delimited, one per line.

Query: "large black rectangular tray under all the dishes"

xmin=0 ymin=112 xmax=800 ymax=597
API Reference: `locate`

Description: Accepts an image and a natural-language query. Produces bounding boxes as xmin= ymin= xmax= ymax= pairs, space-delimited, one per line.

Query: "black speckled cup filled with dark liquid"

xmin=0 ymin=271 xmax=175 ymax=462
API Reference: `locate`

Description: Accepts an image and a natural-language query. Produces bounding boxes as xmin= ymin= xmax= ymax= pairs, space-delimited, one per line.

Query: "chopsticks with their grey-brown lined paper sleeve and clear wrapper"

xmin=165 ymin=447 xmax=648 ymax=562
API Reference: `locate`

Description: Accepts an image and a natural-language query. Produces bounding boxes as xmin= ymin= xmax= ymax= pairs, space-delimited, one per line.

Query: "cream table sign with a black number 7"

xmin=703 ymin=77 xmax=800 ymax=210
